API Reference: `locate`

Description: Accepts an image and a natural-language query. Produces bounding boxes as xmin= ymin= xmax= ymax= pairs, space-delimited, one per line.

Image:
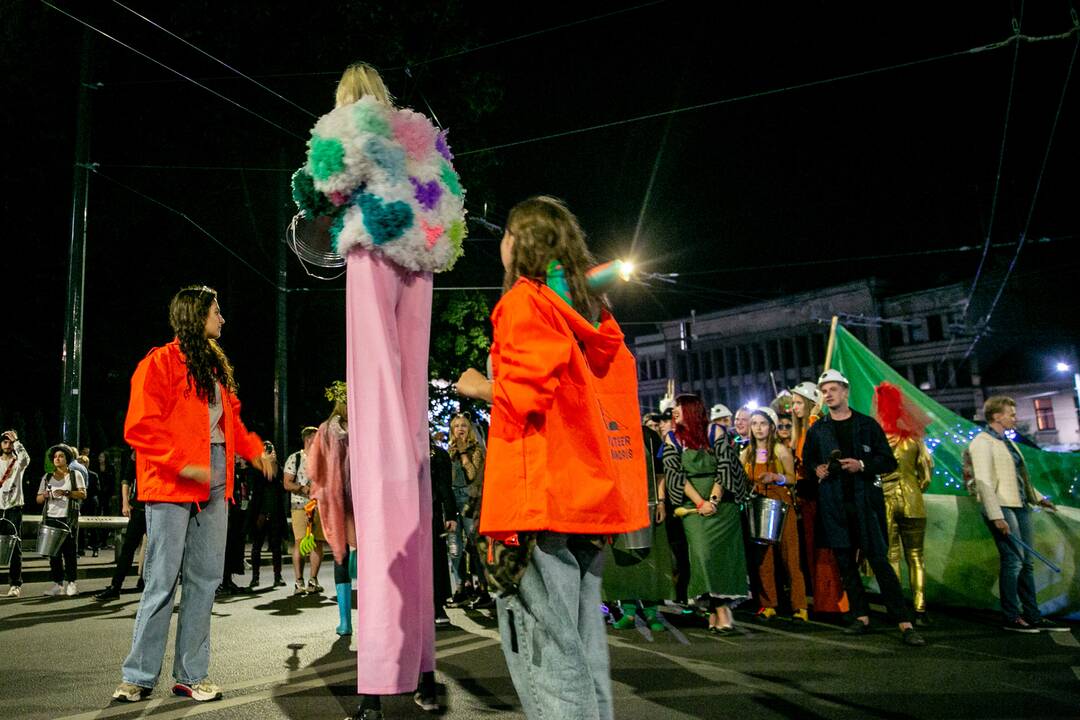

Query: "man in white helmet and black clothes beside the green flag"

xmin=802 ymin=370 xmax=926 ymax=646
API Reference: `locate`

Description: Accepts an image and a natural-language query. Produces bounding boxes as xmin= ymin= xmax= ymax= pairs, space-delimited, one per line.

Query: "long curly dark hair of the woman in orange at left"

xmin=168 ymin=285 xmax=238 ymax=404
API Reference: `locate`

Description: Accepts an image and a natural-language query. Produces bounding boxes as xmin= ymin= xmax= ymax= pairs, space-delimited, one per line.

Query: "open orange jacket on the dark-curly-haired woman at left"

xmin=124 ymin=340 xmax=262 ymax=503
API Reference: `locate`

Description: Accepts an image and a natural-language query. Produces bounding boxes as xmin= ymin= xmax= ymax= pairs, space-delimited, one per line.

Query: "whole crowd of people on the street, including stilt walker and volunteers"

xmin=0 ymin=56 xmax=1063 ymax=720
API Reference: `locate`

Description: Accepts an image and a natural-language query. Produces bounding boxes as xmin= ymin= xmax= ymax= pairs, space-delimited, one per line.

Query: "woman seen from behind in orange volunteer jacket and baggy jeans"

xmin=457 ymin=196 xmax=649 ymax=720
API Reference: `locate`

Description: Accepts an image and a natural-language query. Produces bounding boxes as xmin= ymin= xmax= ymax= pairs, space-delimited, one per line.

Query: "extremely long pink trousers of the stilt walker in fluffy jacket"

xmin=346 ymin=248 xmax=435 ymax=695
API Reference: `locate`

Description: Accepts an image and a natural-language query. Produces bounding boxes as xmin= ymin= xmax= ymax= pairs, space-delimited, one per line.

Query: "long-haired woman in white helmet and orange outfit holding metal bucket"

xmin=741 ymin=407 xmax=809 ymax=623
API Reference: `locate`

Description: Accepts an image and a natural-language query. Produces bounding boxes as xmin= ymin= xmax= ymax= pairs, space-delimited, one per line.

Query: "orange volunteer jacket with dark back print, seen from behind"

xmin=480 ymin=279 xmax=649 ymax=539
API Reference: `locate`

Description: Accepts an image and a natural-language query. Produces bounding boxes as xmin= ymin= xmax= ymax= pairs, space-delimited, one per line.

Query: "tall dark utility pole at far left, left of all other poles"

xmin=59 ymin=29 xmax=93 ymax=446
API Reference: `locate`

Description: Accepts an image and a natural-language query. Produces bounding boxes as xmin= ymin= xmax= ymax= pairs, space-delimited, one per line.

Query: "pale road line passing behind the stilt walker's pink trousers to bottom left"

xmin=57 ymin=637 xmax=495 ymax=720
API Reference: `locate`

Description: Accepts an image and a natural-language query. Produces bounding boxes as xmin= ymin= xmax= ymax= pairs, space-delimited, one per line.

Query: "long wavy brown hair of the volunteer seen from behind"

xmin=502 ymin=195 xmax=604 ymax=320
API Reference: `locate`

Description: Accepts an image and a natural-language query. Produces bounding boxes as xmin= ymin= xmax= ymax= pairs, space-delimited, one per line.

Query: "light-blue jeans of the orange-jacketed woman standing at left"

xmin=122 ymin=445 xmax=229 ymax=688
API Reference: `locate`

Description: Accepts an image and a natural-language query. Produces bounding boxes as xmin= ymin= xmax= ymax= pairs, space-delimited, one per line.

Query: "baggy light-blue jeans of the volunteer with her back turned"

xmin=497 ymin=532 xmax=613 ymax=720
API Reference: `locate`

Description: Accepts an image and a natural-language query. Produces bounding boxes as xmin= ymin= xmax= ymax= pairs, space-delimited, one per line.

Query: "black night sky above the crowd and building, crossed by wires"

xmin=0 ymin=0 xmax=1080 ymax=455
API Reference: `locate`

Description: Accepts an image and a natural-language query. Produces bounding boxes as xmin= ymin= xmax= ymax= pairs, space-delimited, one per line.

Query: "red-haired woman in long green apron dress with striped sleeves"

xmin=663 ymin=395 xmax=750 ymax=634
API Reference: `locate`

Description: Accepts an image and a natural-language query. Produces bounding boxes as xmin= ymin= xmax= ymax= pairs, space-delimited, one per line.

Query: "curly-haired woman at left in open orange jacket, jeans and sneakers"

xmin=112 ymin=286 xmax=274 ymax=703
